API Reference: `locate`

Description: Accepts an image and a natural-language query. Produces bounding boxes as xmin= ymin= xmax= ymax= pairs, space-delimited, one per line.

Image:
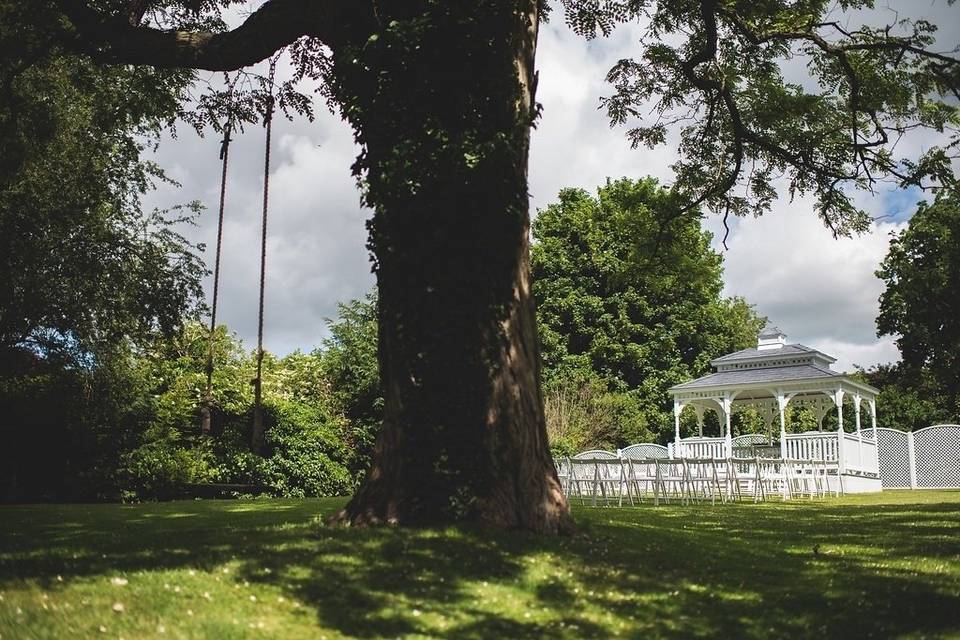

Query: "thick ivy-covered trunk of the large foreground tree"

xmin=334 ymin=0 xmax=572 ymax=533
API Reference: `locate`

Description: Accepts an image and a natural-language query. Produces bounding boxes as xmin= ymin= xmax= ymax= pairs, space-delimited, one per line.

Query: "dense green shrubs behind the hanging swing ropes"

xmin=0 ymin=323 xmax=360 ymax=500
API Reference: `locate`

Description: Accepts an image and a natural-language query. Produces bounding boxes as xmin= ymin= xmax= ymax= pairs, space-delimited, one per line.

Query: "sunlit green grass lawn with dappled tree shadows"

xmin=0 ymin=491 xmax=960 ymax=640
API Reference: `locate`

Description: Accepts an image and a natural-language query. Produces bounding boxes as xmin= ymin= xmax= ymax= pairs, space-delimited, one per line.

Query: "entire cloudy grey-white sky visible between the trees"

xmin=148 ymin=0 xmax=960 ymax=370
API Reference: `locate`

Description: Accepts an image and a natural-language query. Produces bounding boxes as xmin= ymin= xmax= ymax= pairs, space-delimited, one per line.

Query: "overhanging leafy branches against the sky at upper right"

xmin=562 ymin=0 xmax=960 ymax=234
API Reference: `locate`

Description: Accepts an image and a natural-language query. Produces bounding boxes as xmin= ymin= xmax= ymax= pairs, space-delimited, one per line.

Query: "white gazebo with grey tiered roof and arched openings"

xmin=670 ymin=324 xmax=880 ymax=492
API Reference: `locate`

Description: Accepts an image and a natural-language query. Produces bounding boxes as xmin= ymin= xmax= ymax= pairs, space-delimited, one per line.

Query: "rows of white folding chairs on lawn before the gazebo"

xmin=557 ymin=457 xmax=841 ymax=506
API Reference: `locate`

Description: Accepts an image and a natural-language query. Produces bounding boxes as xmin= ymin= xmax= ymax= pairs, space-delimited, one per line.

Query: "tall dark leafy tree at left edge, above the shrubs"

xmin=0 ymin=10 xmax=203 ymax=362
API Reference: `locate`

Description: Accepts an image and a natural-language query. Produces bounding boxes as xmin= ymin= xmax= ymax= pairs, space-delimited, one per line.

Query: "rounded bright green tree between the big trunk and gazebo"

xmin=531 ymin=178 xmax=763 ymax=446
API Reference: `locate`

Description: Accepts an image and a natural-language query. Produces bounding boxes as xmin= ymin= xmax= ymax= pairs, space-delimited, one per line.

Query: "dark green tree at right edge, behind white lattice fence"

xmin=877 ymin=190 xmax=960 ymax=424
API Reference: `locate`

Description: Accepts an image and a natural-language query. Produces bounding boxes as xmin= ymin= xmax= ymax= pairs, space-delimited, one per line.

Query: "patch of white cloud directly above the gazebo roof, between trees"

xmin=711 ymin=199 xmax=905 ymax=370
